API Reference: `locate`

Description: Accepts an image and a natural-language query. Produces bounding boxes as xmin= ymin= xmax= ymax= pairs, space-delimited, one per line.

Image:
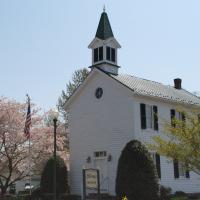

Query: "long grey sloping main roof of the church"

xmin=111 ymin=74 xmax=200 ymax=106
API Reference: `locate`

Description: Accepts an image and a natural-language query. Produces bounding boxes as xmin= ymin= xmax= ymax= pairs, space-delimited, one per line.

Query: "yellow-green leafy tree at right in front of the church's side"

xmin=149 ymin=108 xmax=200 ymax=174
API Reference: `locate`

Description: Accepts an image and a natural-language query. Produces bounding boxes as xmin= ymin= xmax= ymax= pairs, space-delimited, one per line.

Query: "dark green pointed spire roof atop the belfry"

xmin=96 ymin=12 xmax=114 ymax=40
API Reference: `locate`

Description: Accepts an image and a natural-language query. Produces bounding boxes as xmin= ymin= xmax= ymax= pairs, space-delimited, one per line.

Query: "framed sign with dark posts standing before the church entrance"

xmin=83 ymin=168 xmax=100 ymax=200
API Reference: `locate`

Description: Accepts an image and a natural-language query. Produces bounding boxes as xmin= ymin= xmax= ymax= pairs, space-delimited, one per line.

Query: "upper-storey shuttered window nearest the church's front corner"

xmin=140 ymin=103 xmax=158 ymax=130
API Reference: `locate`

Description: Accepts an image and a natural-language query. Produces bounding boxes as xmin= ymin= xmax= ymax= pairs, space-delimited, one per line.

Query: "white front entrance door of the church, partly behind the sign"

xmin=94 ymin=158 xmax=109 ymax=193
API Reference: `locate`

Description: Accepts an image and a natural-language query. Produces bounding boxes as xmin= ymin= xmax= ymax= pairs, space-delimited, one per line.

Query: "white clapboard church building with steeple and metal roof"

xmin=65 ymin=11 xmax=200 ymax=195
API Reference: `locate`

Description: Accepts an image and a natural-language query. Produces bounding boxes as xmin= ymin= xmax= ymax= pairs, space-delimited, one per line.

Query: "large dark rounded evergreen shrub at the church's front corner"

xmin=116 ymin=140 xmax=159 ymax=200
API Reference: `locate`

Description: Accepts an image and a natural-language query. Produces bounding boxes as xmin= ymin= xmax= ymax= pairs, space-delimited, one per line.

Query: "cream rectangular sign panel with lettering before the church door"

xmin=85 ymin=169 xmax=98 ymax=189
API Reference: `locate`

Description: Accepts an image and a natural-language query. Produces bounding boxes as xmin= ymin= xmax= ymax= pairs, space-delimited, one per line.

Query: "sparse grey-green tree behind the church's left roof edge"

xmin=57 ymin=68 xmax=89 ymax=125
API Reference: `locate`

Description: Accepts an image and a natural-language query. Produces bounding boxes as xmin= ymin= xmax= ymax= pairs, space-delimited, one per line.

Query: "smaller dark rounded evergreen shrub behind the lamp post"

xmin=40 ymin=156 xmax=69 ymax=195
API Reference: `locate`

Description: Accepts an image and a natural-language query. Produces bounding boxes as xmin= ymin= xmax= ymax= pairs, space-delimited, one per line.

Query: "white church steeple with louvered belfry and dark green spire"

xmin=88 ymin=7 xmax=121 ymax=75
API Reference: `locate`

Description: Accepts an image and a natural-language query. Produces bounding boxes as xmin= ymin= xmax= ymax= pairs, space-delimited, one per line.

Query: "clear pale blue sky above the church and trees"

xmin=0 ymin=0 xmax=200 ymax=110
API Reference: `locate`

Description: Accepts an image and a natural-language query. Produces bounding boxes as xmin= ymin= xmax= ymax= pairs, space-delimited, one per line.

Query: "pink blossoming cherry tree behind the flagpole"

xmin=0 ymin=97 xmax=67 ymax=195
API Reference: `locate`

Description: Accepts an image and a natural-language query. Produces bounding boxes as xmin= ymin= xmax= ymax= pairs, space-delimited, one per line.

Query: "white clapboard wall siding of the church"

xmin=69 ymin=70 xmax=200 ymax=195
